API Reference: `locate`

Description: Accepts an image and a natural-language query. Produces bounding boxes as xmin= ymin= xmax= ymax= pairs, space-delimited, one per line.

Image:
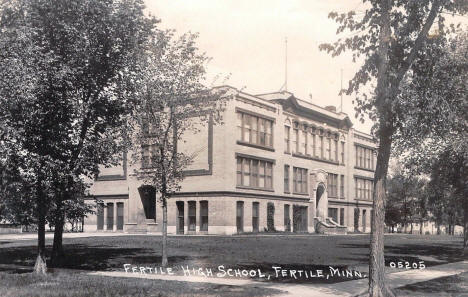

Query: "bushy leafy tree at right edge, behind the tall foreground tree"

xmin=396 ymin=28 xmax=468 ymax=245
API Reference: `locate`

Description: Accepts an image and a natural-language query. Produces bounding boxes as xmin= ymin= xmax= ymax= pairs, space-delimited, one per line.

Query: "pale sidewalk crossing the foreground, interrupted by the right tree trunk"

xmin=89 ymin=261 xmax=468 ymax=297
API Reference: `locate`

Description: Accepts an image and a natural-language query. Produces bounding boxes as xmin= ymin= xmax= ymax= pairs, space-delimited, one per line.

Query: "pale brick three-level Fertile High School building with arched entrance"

xmin=85 ymin=87 xmax=376 ymax=234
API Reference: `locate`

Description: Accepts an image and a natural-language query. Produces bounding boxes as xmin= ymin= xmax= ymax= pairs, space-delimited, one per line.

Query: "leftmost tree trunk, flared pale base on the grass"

xmin=34 ymin=187 xmax=47 ymax=274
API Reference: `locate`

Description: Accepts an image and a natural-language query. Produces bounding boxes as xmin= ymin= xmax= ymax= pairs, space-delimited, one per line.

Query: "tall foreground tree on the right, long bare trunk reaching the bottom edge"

xmin=320 ymin=0 xmax=468 ymax=296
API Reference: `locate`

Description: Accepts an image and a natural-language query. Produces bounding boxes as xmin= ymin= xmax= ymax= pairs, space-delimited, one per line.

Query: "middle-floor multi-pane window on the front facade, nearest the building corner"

xmin=236 ymin=156 xmax=273 ymax=190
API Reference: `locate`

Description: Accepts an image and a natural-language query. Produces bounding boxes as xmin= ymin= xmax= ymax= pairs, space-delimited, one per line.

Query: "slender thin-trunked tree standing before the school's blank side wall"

xmin=131 ymin=31 xmax=224 ymax=267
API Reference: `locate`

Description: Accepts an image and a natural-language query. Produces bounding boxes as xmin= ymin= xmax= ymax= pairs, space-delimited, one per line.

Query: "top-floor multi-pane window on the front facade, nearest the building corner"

xmin=237 ymin=111 xmax=273 ymax=147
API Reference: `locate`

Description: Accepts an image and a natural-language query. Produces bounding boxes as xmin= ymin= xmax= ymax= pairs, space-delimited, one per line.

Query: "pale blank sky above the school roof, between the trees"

xmin=146 ymin=0 xmax=464 ymax=132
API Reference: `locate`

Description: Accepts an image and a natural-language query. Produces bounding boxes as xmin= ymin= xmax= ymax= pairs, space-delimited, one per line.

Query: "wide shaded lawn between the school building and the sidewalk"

xmin=0 ymin=234 xmax=464 ymax=290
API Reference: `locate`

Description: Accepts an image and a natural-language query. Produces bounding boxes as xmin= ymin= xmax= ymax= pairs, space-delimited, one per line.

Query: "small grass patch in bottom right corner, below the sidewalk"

xmin=395 ymin=272 xmax=468 ymax=297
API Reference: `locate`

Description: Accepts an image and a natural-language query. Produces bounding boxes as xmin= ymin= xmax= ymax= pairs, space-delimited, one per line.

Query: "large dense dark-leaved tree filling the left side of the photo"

xmin=0 ymin=0 xmax=156 ymax=272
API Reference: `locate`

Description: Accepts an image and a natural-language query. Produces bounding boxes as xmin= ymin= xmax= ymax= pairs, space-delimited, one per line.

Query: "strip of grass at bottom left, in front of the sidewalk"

xmin=0 ymin=272 xmax=281 ymax=297
